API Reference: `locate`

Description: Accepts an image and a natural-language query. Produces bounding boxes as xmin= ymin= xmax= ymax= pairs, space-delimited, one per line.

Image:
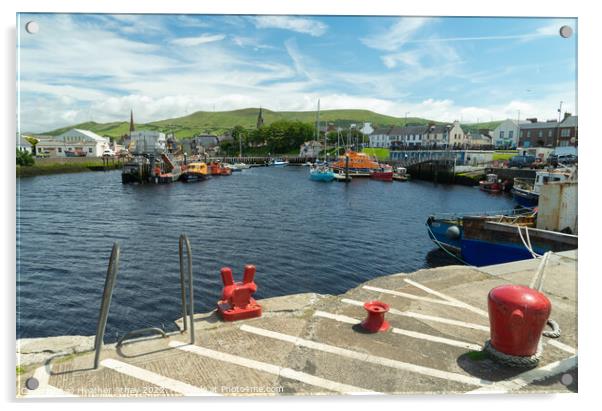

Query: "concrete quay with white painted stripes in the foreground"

xmin=17 ymin=250 xmax=577 ymax=398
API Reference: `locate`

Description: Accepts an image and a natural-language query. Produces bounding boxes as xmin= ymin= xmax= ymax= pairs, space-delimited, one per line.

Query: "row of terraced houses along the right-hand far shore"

xmin=369 ymin=113 xmax=578 ymax=150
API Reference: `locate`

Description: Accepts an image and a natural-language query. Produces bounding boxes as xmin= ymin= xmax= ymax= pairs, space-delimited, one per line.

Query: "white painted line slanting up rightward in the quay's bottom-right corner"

xmin=467 ymin=355 xmax=577 ymax=394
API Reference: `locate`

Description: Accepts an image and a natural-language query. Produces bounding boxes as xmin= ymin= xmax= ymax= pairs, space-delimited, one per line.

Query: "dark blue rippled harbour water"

xmin=17 ymin=167 xmax=513 ymax=341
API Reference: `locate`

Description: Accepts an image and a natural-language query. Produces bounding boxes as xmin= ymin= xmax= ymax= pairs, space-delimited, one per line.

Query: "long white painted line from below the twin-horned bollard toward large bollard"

xmin=240 ymin=325 xmax=493 ymax=386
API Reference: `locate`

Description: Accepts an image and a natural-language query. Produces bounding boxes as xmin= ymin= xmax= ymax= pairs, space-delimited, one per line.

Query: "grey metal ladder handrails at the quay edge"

xmin=94 ymin=234 xmax=194 ymax=369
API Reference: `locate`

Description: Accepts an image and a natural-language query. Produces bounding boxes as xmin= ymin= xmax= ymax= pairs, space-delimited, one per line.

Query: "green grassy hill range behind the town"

xmin=43 ymin=108 xmax=499 ymax=138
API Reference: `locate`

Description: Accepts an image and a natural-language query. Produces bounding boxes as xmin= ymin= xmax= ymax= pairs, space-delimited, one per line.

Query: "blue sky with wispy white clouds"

xmin=17 ymin=14 xmax=577 ymax=132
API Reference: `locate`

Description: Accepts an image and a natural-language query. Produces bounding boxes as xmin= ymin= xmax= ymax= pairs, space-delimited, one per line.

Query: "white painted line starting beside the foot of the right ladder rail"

xmin=169 ymin=341 xmax=382 ymax=395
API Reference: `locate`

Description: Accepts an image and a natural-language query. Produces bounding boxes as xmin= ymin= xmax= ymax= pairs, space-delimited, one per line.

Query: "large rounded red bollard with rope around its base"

xmin=488 ymin=285 xmax=552 ymax=357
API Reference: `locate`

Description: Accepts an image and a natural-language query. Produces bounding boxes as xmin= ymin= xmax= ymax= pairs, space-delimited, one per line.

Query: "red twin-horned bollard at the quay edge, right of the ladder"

xmin=217 ymin=264 xmax=261 ymax=321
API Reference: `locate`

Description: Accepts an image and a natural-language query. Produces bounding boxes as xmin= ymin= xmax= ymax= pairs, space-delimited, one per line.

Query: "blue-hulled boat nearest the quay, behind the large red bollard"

xmin=426 ymin=208 xmax=577 ymax=267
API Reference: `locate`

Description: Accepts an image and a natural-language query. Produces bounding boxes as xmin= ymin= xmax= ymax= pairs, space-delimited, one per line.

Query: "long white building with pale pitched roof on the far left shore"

xmin=36 ymin=128 xmax=110 ymax=157
